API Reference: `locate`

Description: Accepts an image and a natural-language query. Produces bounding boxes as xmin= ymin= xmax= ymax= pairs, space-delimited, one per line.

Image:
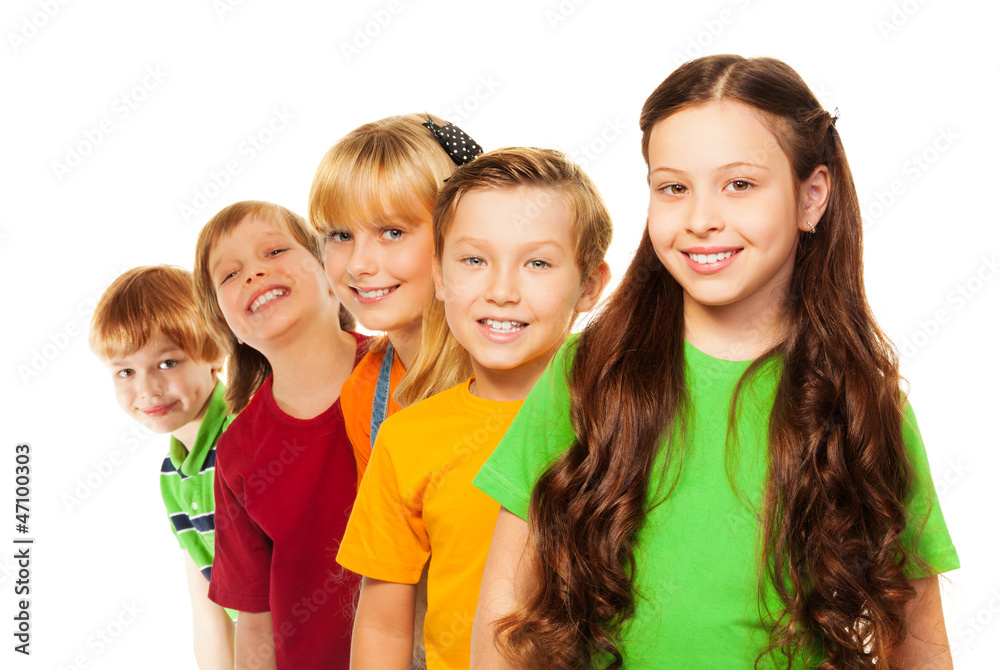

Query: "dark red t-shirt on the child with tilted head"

xmin=208 ymin=334 xmax=364 ymax=669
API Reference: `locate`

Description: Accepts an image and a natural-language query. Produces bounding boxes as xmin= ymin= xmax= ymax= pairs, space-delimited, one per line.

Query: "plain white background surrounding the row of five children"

xmin=0 ymin=0 xmax=1000 ymax=668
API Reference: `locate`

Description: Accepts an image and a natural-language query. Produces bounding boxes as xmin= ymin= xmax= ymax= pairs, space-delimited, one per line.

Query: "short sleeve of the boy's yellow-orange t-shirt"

xmin=337 ymin=431 xmax=431 ymax=584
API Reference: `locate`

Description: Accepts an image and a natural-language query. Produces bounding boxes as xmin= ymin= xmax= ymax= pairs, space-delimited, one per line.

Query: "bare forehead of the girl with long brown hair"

xmin=649 ymin=101 xmax=791 ymax=172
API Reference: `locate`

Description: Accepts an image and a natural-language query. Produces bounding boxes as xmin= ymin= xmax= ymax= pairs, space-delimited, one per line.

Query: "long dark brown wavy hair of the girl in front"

xmin=497 ymin=55 xmax=914 ymax=670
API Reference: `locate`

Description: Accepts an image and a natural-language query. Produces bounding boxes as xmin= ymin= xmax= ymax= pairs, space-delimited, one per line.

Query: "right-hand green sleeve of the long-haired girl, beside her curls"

xmin=900 ymin=402 xmax=959 ymax=578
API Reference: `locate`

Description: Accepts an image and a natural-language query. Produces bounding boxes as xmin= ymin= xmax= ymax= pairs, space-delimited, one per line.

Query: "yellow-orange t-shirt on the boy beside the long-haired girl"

xmin=337 ymin=382 xmax=523 ymax=670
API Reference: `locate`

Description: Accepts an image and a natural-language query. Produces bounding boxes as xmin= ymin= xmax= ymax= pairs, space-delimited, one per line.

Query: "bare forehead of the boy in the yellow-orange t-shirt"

xmin=445 ymin=186 xmax=573 ymax=248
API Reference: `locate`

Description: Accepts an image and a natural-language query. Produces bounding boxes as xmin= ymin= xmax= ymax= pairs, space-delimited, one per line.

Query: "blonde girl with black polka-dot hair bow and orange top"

xmin=309 ymin=114 xmax=482 ymax=482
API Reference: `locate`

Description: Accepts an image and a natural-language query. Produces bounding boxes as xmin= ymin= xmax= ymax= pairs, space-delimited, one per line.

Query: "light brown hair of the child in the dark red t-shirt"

xmin=194 ymin=200 xmax=354 ymax=414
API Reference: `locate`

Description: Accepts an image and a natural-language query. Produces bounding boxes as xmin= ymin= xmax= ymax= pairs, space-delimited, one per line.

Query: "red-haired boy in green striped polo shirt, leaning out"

xmin=90 ymin=265 xmax=233 ymax=670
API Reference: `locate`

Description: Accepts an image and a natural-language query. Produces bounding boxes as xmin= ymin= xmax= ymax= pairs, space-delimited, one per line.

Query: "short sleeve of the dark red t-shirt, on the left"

xmin=208 ymin=446 xmax=274 ymax=612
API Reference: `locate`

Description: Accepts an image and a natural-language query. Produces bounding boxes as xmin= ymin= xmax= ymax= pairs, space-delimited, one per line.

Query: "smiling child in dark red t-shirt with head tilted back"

xmin=195 ymin=202 xmax=364 ymax=668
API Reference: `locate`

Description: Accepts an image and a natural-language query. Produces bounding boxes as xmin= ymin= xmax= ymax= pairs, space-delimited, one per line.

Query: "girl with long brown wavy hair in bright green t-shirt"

xmin=472 ymin=56 xmax=958 ymax=668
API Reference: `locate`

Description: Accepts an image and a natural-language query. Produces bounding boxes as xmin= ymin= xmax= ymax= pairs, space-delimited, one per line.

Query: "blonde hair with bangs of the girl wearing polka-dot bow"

xmin=309 ymin=114 xmax=471 ymax=407
